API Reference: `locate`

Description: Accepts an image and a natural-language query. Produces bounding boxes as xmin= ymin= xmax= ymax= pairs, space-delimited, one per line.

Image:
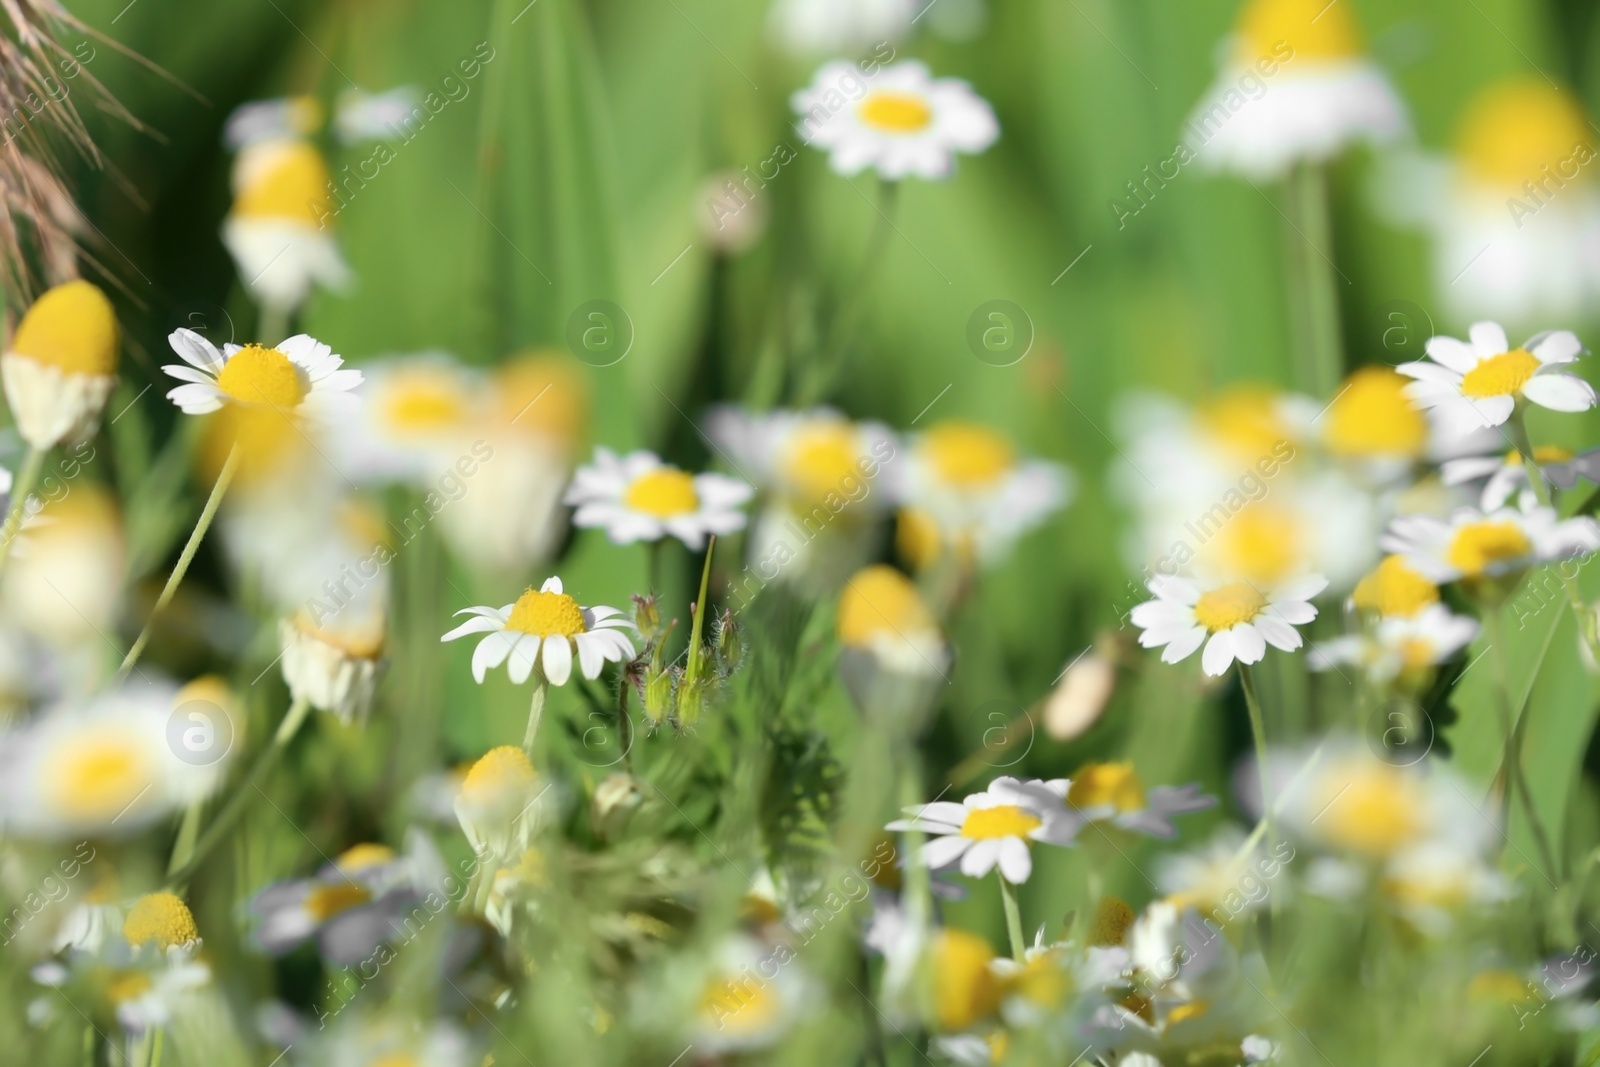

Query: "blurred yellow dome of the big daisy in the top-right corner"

xmin=1458 ymin=78 xmax=1594 ymax=194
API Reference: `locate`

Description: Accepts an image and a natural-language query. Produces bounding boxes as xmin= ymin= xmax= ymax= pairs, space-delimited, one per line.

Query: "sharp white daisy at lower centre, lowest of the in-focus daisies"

xmin=886 ymin=777 xmax=1080 ymax=885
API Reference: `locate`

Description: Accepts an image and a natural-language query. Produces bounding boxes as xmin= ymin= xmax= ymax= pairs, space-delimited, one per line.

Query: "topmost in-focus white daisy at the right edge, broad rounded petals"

xmin=1397 ymin=322 xmax=1595 ymax=434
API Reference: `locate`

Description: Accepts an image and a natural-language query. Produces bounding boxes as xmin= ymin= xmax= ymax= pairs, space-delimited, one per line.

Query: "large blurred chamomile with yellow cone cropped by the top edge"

xmin=1186 ymin=0 xmax=1406 ymax=179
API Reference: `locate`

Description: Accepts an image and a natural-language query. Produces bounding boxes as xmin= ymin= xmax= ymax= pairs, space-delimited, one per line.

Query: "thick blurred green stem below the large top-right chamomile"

xmin=1288 ymin=163 xmax=1344 ymax=397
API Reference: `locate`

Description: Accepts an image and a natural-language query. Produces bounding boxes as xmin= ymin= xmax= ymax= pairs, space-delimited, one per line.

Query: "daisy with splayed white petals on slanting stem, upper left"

xmin=162 ymin=330 xmax=362 ymax=422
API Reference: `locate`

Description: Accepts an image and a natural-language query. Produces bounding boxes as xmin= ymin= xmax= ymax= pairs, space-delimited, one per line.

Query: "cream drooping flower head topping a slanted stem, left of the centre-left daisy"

xmin=278 ymin=606 xmax=386 ymax=723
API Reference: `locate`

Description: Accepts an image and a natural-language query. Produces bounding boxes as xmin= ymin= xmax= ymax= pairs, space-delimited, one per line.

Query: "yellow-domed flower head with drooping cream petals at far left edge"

xmin=0 ymin=282 xmax=120 ymax=450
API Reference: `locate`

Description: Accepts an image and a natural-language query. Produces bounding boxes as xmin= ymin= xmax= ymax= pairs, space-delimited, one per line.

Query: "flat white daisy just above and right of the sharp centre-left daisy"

xmin=563 ymin=448 xmax=755 ymax=549
